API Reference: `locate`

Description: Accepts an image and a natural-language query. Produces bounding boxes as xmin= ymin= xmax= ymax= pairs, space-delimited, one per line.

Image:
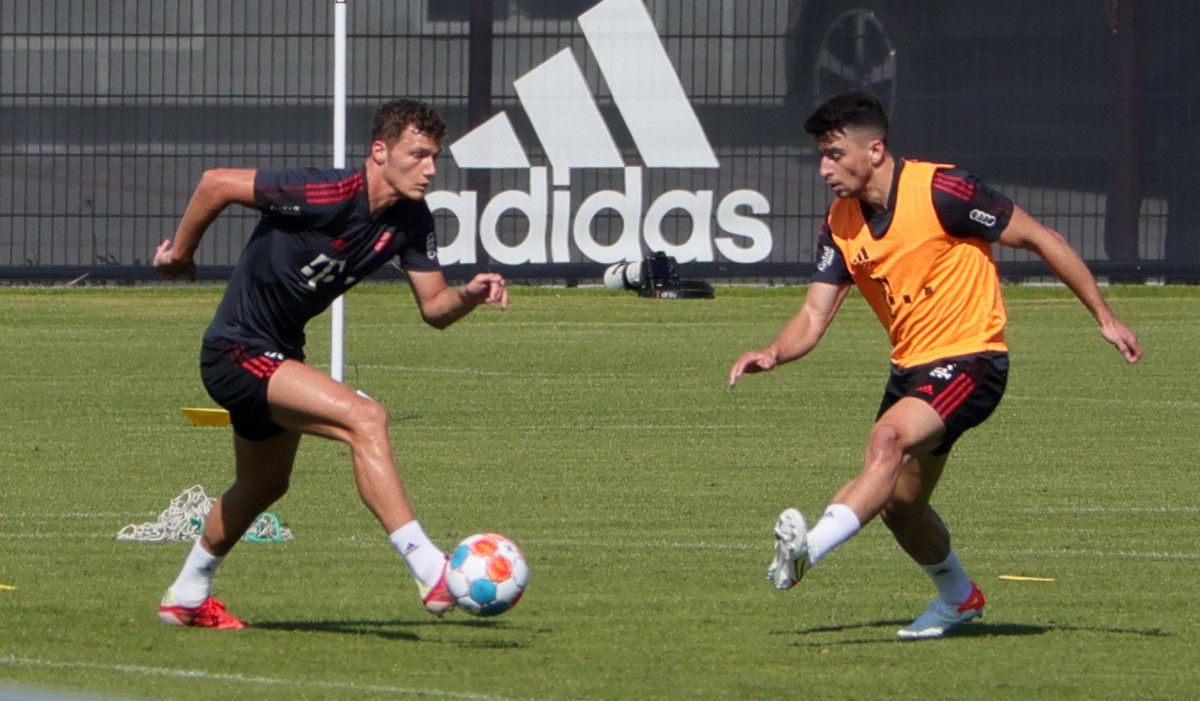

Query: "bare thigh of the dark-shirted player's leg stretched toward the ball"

xmin=266 ymin=360 xmax=386 ymax=441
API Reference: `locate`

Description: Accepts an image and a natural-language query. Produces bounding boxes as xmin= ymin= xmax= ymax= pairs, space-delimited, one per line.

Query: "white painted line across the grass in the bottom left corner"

xmin=0 ymin=655 xmax=525 ymax=701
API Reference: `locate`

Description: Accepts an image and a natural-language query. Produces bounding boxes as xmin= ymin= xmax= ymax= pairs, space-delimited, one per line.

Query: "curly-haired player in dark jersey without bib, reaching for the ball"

xmin=154 ymin=100 xmax=509 ymax=628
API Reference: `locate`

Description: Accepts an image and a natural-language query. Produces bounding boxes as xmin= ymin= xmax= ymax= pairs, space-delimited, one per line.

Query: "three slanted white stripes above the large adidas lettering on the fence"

xmin=450 ymin=0 xmax=719 ymax=185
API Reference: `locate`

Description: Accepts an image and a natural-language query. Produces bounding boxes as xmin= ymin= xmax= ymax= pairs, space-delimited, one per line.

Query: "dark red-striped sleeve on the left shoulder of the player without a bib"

xmin=254 ymin=168 xmax=365 ymax=228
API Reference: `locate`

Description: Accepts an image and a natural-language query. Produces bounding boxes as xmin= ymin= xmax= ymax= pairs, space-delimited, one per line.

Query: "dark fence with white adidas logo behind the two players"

xmin=0 ymin=0 xmax=1200 ymax=281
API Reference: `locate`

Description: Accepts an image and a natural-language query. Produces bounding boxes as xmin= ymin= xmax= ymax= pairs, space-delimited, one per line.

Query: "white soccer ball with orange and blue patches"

xmin=446 ymin=533 xmax=529 ymax=616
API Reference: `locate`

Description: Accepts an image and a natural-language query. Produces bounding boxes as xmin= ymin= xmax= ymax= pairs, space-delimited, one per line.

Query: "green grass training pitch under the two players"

xmin=0 ymin=284 xmax=1200 ymax=700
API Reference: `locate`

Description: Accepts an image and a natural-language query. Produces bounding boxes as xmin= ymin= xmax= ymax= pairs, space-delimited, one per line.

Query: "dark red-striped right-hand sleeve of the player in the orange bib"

xmin=932 ymin=168 xmax=1013 ymax=241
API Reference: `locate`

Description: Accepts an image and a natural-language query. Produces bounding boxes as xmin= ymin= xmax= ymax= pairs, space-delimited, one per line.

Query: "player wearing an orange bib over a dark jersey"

xmin=728 ymin=92 xmax=1141 ymax=640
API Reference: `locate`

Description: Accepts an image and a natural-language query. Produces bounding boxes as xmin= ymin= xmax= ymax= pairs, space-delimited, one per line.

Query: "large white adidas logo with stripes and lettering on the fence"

xmin=426 ymin=0 xmax=772 ymax=265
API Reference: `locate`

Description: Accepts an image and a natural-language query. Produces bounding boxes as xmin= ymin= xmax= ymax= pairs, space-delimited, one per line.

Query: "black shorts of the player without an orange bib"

xmin=200 ymin=341 xmax=286 ymax=441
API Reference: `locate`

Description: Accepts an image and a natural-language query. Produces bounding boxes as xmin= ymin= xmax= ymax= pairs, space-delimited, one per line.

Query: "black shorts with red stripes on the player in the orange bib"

xmin=875 ymin=352 xmax=1008 ymax=455
